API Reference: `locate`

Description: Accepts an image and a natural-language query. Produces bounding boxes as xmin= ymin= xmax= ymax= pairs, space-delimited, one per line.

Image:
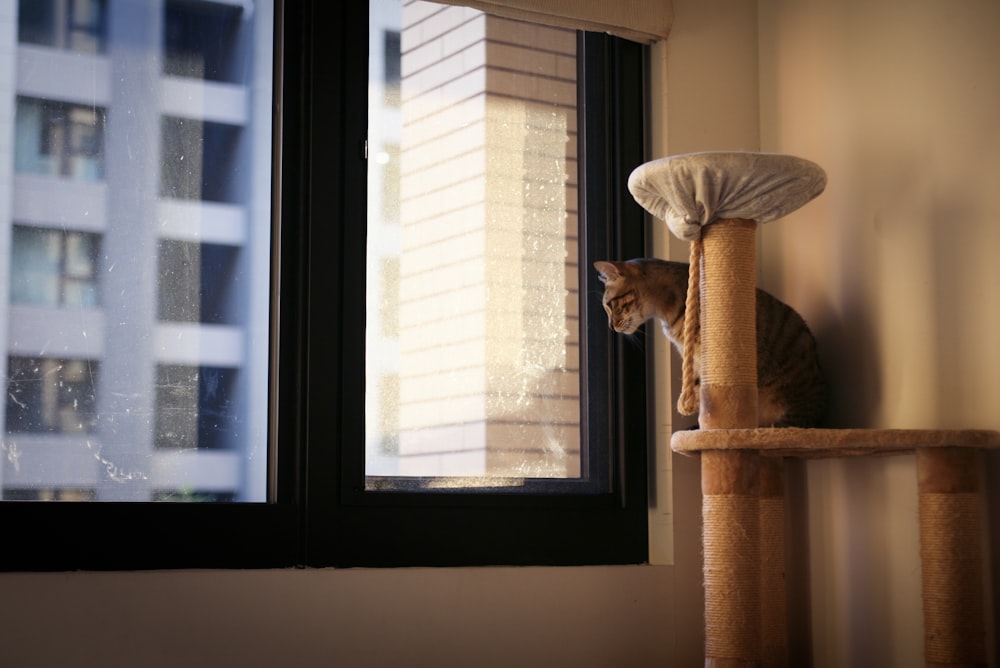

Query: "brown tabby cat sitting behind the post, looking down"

xmin=594 ymin=258 xmax=827 ymax=427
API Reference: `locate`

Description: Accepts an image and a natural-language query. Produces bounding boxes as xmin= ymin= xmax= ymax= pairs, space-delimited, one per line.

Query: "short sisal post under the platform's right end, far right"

xmin=917 ymin=448 xmax=986 ymax=667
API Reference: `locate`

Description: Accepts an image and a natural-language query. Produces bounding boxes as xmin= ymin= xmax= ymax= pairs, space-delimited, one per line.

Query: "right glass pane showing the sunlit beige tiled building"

xmin=366 ymin=0 xmax=586 ymax=487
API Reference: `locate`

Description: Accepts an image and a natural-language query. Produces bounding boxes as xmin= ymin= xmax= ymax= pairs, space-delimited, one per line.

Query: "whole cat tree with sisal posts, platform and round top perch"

xmin=628 ymin=152 xmax=1000 ymax=668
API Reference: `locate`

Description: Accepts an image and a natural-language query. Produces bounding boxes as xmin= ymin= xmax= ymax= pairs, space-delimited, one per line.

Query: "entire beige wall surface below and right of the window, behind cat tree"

xmin=0 ymin=0 xmax=1000 ymax=668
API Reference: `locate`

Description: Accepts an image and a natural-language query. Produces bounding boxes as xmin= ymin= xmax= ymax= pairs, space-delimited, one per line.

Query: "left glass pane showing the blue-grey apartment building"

xmin=0 ymin=0 xmax=274 ymax=502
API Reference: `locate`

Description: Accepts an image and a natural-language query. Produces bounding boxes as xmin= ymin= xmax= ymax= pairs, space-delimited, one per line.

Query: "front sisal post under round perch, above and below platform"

xmin=699 ymin=219 xmax=762 ymax=668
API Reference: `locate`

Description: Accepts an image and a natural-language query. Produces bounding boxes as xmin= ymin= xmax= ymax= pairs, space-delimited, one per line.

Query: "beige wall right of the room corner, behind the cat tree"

xmin=758 ymin=0 xmax=1000 ymax=666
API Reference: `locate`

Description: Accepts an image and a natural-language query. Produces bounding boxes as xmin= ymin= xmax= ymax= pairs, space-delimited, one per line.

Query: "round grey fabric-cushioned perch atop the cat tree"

xmin=628 ymin=151 xmax=826 ymax=241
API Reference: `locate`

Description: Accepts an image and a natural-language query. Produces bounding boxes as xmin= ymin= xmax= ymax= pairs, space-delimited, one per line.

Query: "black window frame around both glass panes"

xmin=0 ymin=0 xmax=651 ymax=571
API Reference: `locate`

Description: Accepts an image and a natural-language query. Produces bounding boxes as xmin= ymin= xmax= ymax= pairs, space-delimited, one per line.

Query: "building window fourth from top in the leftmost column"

xmin=6 ymin=357 xmax=100 ymax=434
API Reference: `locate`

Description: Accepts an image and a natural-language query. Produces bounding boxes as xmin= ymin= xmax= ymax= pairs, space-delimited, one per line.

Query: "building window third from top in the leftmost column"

xmin=10 ymin=225 xmax=101 ymax=308
